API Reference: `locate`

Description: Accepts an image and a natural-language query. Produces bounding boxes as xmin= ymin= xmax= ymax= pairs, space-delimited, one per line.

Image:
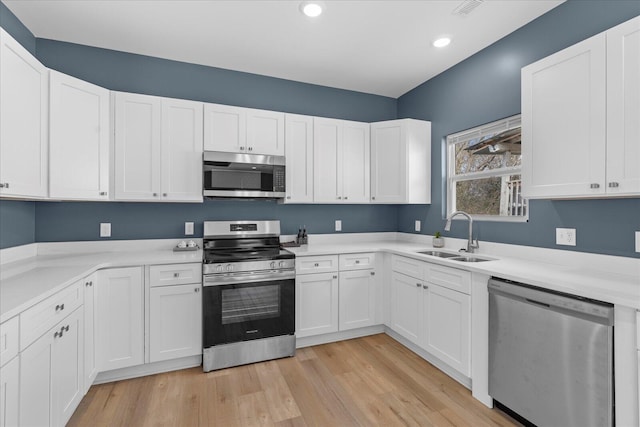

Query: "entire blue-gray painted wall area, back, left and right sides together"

xmin=0 ymin=0 xmax=640 ymax=257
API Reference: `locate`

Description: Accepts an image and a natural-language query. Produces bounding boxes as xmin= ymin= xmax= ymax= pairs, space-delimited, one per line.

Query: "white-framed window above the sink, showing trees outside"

xmin=446 ymin=115 xmax=528 ymax=221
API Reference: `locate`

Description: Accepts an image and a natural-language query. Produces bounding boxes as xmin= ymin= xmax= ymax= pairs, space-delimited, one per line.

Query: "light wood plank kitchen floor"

xmin=68 ymin=334 xmax=519 ymax=427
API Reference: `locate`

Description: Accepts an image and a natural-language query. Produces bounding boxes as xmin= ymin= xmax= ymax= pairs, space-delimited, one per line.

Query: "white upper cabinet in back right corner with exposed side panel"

xmin=371 ymin=119 xmax=431 ymax=204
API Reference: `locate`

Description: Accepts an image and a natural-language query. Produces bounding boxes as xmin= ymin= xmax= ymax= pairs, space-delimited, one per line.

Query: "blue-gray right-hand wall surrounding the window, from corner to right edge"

xmin=398 ymin=0 xmax=640 ymax=257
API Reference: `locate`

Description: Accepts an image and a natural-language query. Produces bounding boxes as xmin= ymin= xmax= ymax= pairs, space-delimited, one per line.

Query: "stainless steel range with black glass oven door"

xmin=202 ymin=221 xmax=296 ymax=372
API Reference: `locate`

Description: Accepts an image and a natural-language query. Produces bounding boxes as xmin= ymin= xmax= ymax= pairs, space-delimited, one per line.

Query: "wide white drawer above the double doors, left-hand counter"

xmin=20 ymin=280 xmax=84 ymax=350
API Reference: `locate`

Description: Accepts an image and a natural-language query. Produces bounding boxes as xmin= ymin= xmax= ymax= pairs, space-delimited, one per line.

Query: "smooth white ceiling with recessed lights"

xmin=2 ymin=0 xmax=562 ymax=98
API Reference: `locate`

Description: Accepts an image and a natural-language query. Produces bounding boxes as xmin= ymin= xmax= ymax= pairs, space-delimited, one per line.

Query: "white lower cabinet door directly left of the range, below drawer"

xmin=149 ymin=283 xmax=202 ymax=362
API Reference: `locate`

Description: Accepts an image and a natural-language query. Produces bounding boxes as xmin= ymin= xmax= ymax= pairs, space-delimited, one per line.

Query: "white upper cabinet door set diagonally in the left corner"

xmin=49 ymin=70 xmax=109 ymax=200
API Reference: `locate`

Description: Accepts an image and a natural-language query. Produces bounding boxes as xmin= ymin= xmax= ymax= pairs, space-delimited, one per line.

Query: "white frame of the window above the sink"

xmin=444 ymin=114 xmax=530 ymax=223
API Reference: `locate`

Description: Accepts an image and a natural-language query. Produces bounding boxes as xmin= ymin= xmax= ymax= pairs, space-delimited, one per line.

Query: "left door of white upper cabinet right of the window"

xmin=522 ymin=34 xmax=606 ymax=198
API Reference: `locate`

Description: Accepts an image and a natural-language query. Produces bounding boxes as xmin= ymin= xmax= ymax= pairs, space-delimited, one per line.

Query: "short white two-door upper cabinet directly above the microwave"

xmin=204 ymin=104 xmax=285 ymax=156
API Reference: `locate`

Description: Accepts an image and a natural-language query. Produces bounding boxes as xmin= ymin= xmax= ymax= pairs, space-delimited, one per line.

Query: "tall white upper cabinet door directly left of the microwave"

xmin=161 ymin=98 xmax=203 ymax=202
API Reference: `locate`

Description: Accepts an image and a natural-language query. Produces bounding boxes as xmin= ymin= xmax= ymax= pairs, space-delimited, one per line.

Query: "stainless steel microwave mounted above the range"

xmin=202 ymin=151 xmax=285 ymax=199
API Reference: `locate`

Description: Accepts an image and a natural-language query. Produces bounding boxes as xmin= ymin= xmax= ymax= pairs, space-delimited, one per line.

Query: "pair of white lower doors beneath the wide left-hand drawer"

xmin=19 ymin=308 xmax=84 ymax=426
